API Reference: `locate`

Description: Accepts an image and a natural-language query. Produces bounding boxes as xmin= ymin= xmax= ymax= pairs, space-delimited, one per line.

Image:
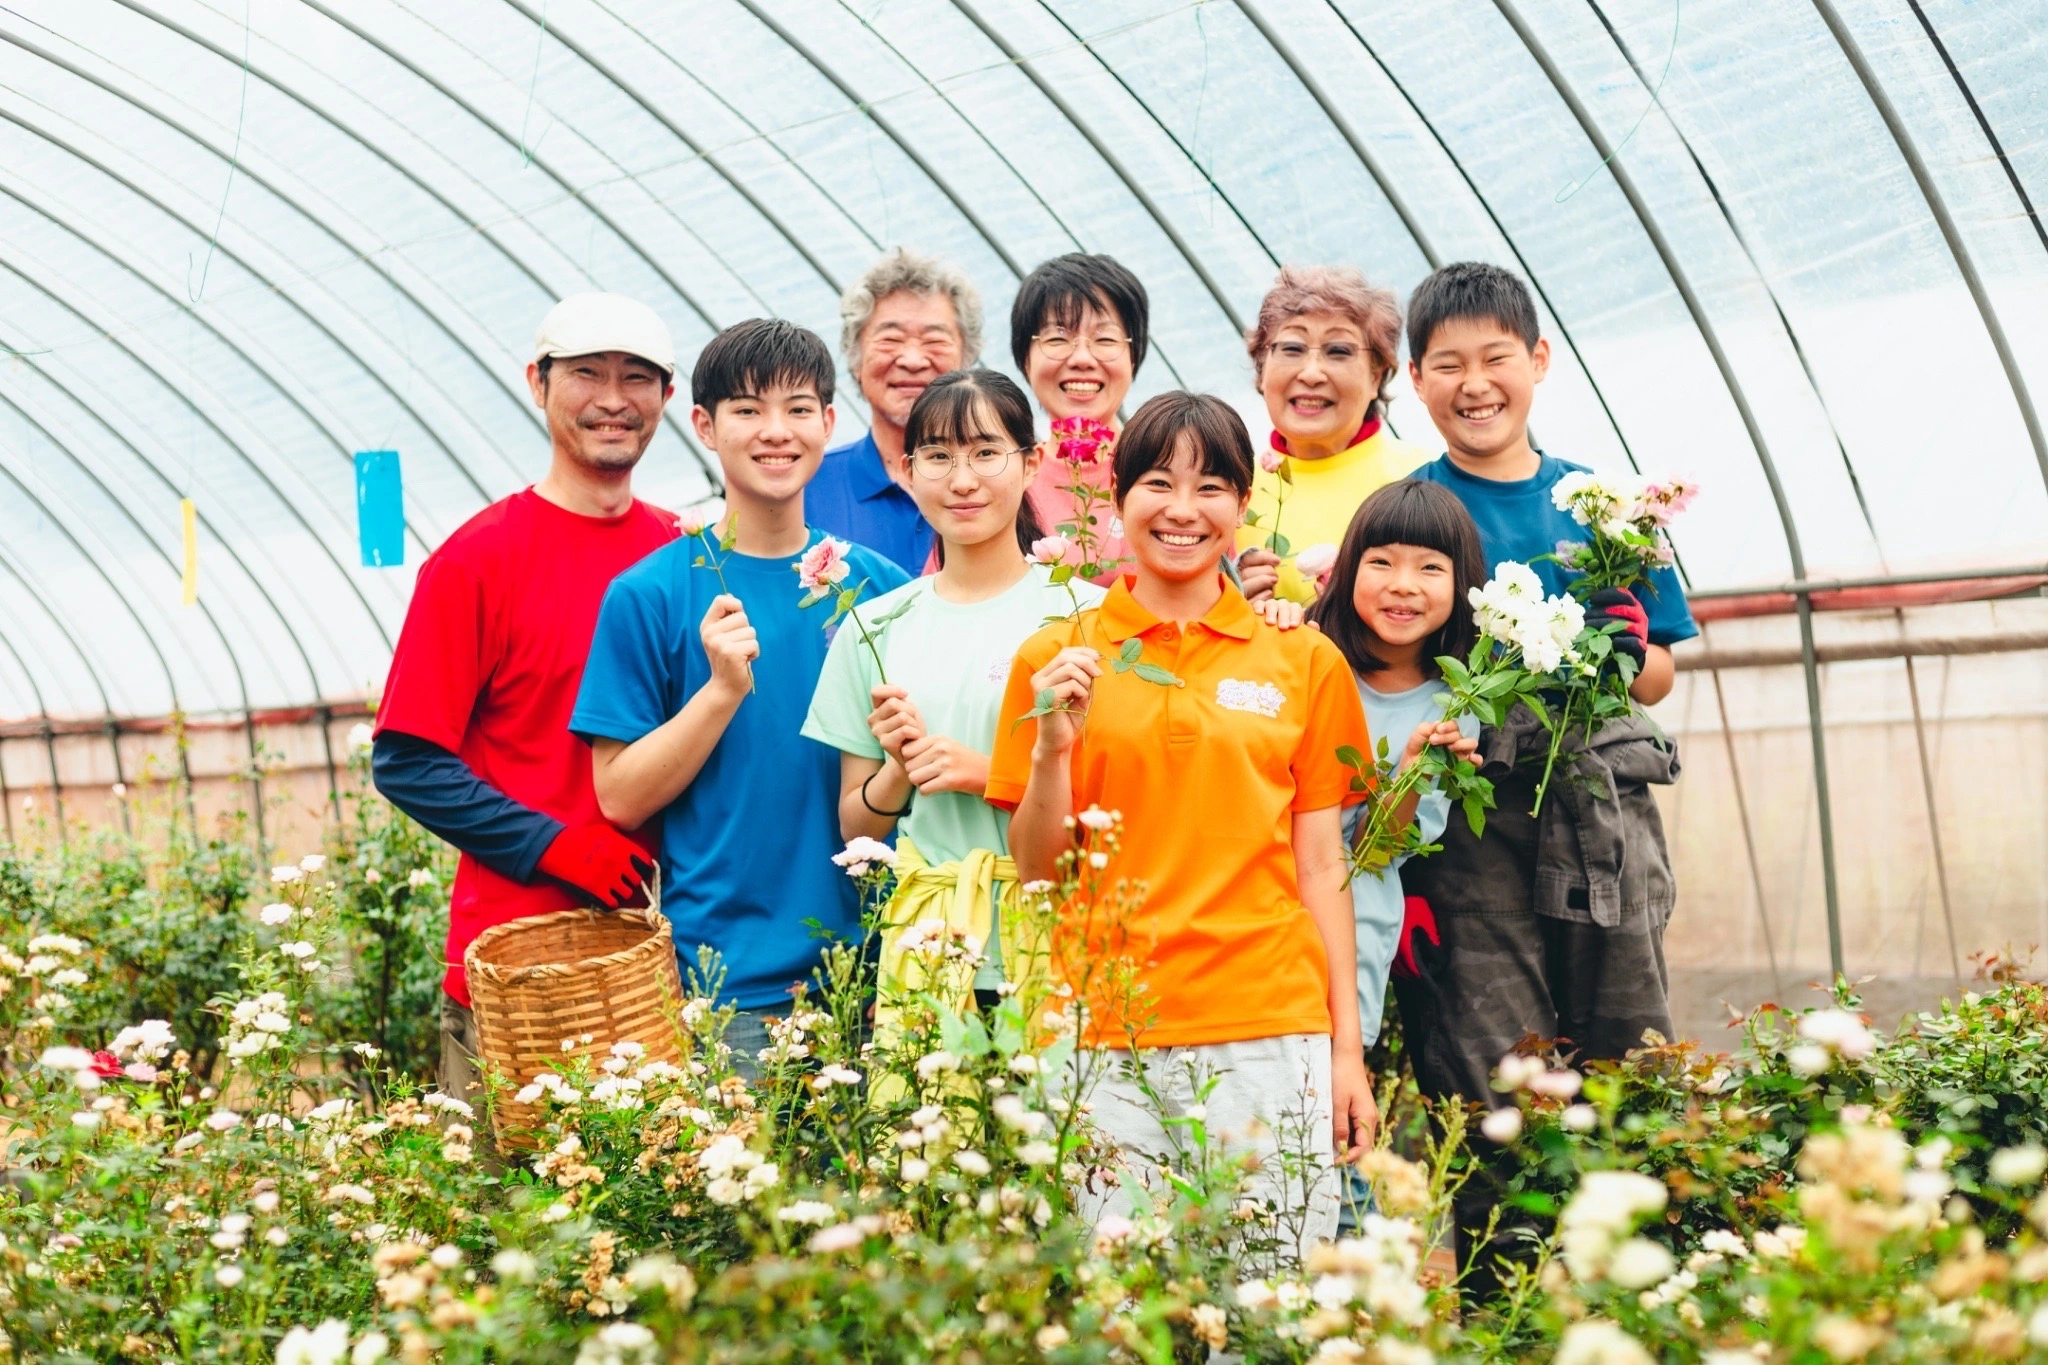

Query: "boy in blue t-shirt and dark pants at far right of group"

xmin=1395 ymin=262 xmax=1698 ymax=1285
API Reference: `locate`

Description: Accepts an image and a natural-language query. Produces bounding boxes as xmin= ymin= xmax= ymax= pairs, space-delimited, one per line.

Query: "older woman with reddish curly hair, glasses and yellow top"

xmin=1237 ymin=266 xmax=1430 ymax=604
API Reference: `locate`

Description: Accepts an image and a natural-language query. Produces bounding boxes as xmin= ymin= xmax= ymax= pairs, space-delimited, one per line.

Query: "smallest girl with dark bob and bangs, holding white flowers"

xmin=1309 ymin=481 xmax=1487 ymax=1226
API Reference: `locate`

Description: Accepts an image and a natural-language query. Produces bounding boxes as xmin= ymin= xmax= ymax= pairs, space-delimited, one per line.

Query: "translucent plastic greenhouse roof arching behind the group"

xmin=0 ymin=0 xmax=2048 ymax=718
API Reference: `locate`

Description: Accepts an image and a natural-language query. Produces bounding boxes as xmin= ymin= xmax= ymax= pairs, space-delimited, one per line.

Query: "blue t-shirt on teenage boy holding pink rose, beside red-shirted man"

xmin=569 ymin=528 xmax=907 ymax=1009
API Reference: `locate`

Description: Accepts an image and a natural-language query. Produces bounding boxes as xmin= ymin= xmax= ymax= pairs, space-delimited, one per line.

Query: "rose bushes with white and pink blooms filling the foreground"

xmin=0 ymin=785 xmax=2048 ymax=1365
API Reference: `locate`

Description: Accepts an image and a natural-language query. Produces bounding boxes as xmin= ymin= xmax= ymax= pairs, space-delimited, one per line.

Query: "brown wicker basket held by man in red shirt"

xmin=463 ymin=911 xmax=682 ymax=1148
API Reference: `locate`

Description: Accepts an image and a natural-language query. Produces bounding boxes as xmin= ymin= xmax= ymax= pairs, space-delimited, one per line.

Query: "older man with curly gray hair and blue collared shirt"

xmin=803 ymin=248 xmax=981 ymax=575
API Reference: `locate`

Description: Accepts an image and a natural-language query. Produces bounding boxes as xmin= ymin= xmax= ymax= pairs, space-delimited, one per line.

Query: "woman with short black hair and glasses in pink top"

xmin=1010 ymin=254 xmax=1151 ymax=583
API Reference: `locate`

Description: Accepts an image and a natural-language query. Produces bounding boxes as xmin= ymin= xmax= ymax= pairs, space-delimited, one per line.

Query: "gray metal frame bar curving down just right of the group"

xmin=1493 ymin=0 xmax=1843 ymax=976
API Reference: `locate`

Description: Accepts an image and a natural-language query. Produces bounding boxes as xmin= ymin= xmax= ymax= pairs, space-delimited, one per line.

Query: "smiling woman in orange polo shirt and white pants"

xmin=987 ymin=393 xmax=1378 ymax=1250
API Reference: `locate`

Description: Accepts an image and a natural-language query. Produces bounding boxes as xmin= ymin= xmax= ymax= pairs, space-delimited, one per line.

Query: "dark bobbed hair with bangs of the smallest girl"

xmin=1309 ymin=479 xmax=1487 ymax=679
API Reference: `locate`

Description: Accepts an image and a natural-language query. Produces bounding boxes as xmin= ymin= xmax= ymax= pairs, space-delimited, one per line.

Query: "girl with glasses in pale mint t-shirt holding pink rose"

xmin=803 ymin=368 xmax=1102 ymax=1019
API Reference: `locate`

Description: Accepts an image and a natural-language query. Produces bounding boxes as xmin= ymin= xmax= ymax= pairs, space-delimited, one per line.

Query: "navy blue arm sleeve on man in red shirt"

xmin=371 ymin=731 xmax=565 ymax=884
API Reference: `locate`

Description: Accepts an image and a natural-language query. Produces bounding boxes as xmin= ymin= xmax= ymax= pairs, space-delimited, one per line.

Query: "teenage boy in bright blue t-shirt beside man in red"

xmin=569 ymin=319 xmax=907 ymax=1070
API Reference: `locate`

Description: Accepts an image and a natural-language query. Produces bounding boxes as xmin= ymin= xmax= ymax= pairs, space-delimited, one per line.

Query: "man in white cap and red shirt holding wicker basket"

xmin=371 ymin=295 xmax=678 ymax=1099
